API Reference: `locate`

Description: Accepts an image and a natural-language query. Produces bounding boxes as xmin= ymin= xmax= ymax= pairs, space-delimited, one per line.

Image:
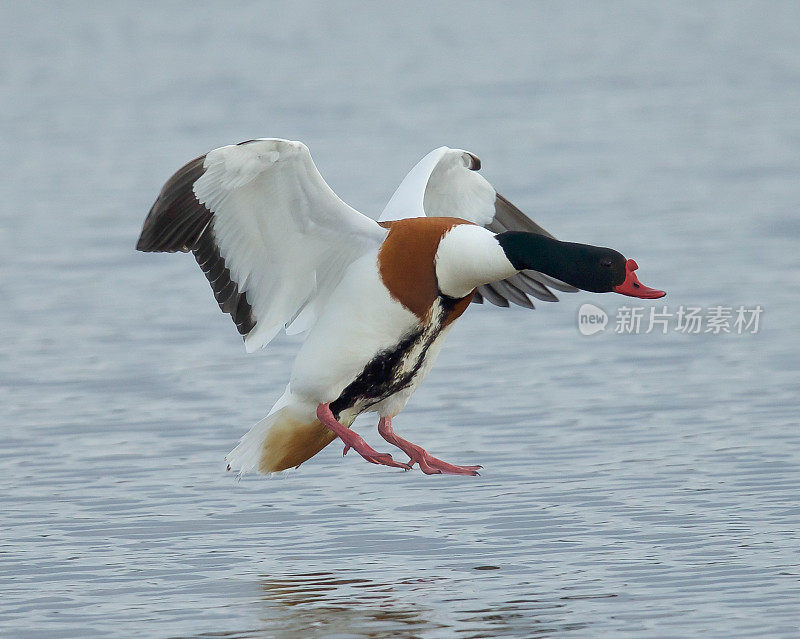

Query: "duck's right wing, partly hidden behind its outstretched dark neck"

xmin=380 ymin=146 xmax=578 ymax=308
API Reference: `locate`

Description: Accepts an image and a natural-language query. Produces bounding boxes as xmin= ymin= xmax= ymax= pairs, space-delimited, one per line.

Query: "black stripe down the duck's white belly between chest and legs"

xmin=330 ymin=296 xmax=457 ymax=419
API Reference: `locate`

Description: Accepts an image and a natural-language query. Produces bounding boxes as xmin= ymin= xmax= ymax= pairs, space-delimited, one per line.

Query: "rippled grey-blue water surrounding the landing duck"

xmin=0 ymin=2 xmax=800 ymax=638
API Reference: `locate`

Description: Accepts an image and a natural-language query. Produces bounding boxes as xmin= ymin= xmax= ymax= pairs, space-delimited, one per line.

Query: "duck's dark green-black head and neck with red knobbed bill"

xmin=496 ymin=231 xmax=666 ymax=299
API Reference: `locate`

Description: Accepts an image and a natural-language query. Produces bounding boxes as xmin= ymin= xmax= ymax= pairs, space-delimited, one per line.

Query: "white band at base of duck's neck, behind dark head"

xmin=436 ymin=224 xmax=517 ymax=298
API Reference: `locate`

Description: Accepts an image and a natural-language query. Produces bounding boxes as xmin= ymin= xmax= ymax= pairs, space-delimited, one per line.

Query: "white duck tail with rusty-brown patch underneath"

xmin=225 ymin=389 xmax=336 ymax=475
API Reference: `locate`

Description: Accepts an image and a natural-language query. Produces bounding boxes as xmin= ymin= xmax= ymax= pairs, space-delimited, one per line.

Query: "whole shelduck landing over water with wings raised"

xmin=136 ymin=138 xmax=665 ymax=476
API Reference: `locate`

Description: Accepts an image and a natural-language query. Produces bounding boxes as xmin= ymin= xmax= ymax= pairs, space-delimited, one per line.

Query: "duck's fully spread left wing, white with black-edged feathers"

xmin=136 ymin=139 xmax=386 ymax=352
